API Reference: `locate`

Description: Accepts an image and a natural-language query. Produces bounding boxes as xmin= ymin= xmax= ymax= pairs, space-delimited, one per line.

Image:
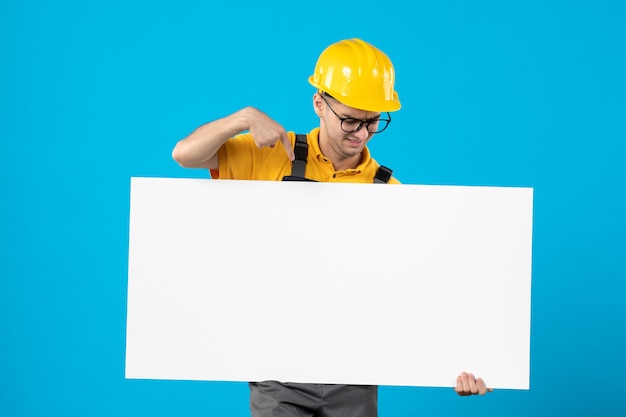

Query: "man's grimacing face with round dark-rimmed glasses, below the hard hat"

xmin=313 ymin=93 xmax=380 ymax=160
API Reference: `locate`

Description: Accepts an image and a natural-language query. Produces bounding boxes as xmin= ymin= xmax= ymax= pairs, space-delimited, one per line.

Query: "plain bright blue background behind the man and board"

xmin=0 ymin=0 xmax=626 ymax=417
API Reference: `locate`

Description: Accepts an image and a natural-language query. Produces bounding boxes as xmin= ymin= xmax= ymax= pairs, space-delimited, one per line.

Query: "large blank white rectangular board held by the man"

xmin=126 ymin=178 xmax=532 ymax=389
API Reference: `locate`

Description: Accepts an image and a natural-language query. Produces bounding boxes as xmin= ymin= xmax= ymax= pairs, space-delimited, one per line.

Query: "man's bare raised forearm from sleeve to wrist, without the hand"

xmin=172 ymin=108 xmax=250 ymax=169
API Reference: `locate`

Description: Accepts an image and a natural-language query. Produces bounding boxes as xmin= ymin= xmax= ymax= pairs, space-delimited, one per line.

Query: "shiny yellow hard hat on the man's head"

xmin=309 ymin=38 xmax=400 ymax=112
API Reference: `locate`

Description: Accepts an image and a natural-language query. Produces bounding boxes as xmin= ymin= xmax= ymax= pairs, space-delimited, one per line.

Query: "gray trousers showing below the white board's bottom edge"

xmin=250 ymin=381 xmax=378 ymax=417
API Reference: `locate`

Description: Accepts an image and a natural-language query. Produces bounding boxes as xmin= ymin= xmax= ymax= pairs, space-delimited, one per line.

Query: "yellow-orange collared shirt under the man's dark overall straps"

xmin=211 ymin=128 xmax=399 ymax=184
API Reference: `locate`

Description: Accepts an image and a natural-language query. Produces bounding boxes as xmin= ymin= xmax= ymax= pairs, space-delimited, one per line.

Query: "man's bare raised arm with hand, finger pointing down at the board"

xmin=172 ymin=107 xmax=294 ymax=169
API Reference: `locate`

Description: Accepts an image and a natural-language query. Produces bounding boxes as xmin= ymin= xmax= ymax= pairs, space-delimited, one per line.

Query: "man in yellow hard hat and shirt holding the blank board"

xmin=172 ymin=39 xmax=491 ymax=417
